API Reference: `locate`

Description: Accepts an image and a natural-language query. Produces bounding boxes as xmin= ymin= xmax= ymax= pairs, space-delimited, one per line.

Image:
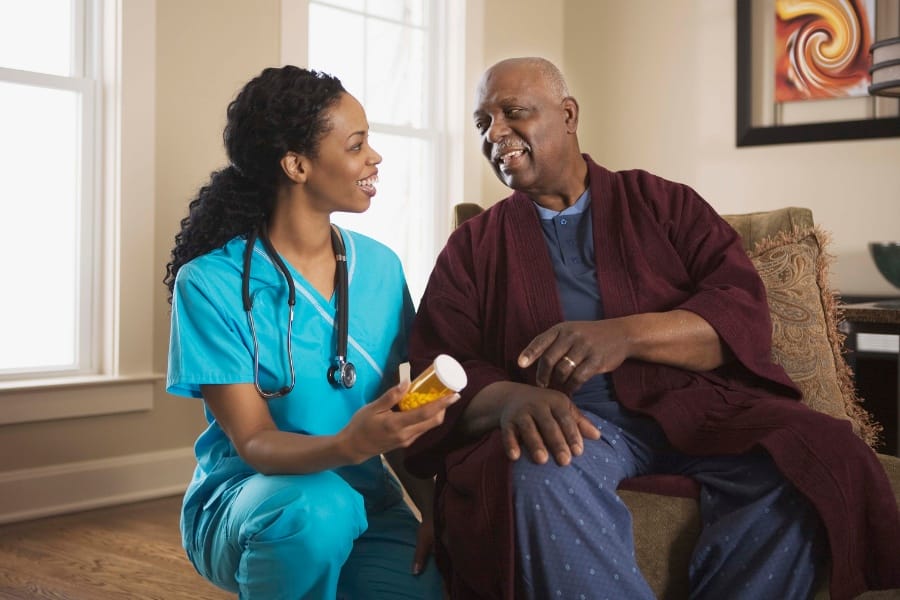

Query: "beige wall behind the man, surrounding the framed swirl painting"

xmin=563 ymin=0 xmax=900 ymax=294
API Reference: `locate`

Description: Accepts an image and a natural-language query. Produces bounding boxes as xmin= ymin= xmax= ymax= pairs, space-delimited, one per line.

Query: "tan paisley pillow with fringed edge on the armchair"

xmin=747 ymin=227 xmax=881 ymax=448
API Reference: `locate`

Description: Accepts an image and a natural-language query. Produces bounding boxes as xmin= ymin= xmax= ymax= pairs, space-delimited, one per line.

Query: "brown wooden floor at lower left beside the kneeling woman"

xmin=0 ymin=497 xmax=236 ymax=600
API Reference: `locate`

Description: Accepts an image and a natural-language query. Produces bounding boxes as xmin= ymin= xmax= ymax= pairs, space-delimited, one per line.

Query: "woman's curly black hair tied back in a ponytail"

xmin=163 ymin=65 xmax=345 ymax=302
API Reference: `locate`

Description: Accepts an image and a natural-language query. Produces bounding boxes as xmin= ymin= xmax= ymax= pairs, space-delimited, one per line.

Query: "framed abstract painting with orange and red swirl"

xmin=736 ymin=0 xmax=900 ymax=147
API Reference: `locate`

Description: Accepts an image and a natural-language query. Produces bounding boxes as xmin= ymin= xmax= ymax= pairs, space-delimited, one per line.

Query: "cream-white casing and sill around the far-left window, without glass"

xmin=0 ymin=0 xmax=163 ymax=425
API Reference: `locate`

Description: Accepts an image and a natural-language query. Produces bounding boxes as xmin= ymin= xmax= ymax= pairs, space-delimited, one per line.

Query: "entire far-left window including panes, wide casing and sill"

xmin=0 ymin=0 xmax=161 ymax=424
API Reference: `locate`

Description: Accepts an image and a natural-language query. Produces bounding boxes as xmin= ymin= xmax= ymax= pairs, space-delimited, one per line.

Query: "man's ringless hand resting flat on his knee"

xmin=500 ymin=384 xmax=600 ymax=466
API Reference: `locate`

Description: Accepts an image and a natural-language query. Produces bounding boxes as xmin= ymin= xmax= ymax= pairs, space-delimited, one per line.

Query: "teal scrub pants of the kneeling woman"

xmin=187 ymin=471 xmax=443 ymax=600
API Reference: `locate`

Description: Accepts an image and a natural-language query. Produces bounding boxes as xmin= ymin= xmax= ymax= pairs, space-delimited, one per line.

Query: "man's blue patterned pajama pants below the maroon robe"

xmin=513 ymin=402 xmax=827 ymax=600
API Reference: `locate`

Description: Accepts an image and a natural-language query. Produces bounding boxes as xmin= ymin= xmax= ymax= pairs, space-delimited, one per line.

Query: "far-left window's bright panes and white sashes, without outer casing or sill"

xmin=0 ymin=0 xmax=99 ymax=378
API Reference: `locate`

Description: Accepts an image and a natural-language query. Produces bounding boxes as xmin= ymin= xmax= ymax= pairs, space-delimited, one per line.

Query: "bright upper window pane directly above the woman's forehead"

xmin=309 ymin=4 xmax=366 ymax=98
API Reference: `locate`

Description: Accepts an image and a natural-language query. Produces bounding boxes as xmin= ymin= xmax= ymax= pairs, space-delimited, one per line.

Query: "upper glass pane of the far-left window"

xmin=0 ymin=0 xmax=74 ymax=76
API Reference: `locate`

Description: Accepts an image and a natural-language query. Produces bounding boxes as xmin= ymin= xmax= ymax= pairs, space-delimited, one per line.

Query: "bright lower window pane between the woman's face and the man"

xmin=333 ymin=132 xmax=434 ymax=303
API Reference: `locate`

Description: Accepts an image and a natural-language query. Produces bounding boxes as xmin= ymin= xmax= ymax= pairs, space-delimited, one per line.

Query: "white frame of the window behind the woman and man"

xmin=281 ymin=0 xmax=469 ymax=303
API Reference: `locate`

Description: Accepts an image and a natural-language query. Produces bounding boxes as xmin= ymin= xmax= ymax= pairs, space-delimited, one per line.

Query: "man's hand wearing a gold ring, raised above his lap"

xmin=519 ymin=319 xmax=630 ymax=394
